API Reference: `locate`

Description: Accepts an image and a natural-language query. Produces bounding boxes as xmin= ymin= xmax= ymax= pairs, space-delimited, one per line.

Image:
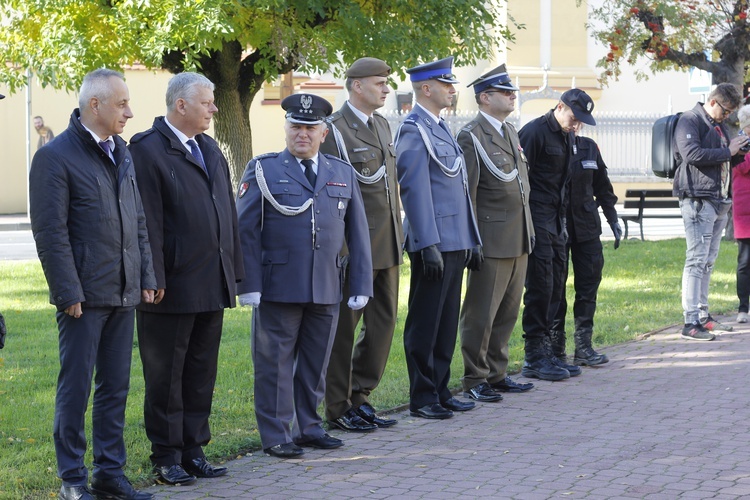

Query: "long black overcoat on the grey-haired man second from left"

xmin=130 ymin=117 xmax=245 ymax=313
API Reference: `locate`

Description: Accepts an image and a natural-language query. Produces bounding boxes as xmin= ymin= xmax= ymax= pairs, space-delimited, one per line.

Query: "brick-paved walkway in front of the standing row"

xmin=149 ymin=317 xmax=750 ymax=500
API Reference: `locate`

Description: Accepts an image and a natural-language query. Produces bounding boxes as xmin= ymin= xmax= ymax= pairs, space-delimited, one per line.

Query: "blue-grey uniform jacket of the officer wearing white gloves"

xmin=237 ymin=149 xmax=372 ymax=304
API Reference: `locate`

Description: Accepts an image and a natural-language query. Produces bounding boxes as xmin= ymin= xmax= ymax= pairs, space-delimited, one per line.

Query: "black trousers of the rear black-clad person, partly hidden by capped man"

xmin=550 ymin=238 xmax=604 ymax=332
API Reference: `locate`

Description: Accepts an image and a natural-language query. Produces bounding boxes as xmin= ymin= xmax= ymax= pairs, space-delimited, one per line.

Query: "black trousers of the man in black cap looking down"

xmin=521 ymin=229 xmax=567 ymax=340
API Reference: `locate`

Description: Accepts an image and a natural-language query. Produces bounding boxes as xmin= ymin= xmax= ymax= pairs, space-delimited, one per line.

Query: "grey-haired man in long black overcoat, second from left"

xmin=130 ymin=73 xmax=244 ymax=484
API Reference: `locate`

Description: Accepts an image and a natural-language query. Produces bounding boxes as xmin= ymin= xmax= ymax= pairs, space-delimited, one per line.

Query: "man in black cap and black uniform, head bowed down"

xmin=518 ymin=89 xmax=596 ymax=381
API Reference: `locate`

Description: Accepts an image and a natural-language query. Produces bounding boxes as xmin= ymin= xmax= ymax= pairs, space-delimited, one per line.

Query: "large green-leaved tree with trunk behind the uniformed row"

xmin=0 ymin=0 xmax=513 ymax=181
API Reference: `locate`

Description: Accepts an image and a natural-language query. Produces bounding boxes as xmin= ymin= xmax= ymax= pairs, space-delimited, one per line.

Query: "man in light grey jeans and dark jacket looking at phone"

xmin=672 ymin=83 xmax=748 ymax=340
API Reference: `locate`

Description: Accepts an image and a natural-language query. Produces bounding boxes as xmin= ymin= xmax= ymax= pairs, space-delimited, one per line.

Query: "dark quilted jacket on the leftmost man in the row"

xmin=29 ymin=109 xmax=156 ymax=311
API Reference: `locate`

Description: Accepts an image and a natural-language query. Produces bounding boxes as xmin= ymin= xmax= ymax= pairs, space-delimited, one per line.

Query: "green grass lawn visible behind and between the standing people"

xmin=0 ymin=239 xmax=737 ymax=499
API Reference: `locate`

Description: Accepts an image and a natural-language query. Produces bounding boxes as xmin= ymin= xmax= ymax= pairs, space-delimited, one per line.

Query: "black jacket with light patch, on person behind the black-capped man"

xmin=568 ymin=137 xmax=617 ymax=241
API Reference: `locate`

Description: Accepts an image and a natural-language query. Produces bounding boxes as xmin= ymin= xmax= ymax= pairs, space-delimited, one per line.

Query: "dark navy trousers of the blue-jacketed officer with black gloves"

xmin=404 ymin=250 xmax=466 ymax=410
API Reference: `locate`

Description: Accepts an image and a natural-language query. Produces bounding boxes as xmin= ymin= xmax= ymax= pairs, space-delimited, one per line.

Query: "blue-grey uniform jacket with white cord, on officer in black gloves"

xmin=396 ymin=106 xmax=480 ymax=252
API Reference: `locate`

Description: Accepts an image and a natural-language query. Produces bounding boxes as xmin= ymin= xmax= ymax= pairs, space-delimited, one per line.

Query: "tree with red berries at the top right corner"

xmin=590 ymin=0 xmax=750 ymax=92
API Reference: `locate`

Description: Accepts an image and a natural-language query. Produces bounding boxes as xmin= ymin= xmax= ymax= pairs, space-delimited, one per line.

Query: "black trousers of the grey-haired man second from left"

xmin=136 ymin=309 xmax=224 ymax=465
